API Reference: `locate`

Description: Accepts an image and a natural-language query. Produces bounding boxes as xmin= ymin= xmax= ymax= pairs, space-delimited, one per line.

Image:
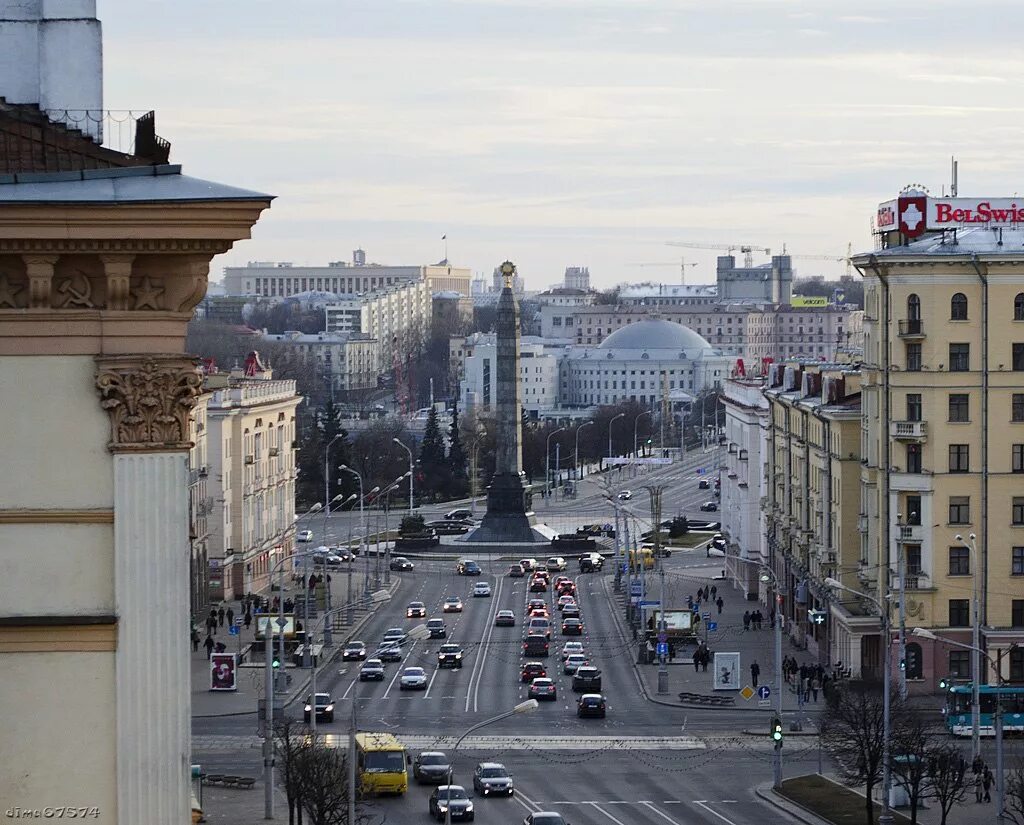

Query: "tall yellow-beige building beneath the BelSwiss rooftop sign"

xmin=854 ymin=224 xmax=1024 ymax=691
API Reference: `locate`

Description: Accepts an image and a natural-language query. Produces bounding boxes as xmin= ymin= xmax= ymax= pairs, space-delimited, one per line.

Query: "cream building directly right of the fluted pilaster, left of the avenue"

xmin=206 ymin=355 xmax=302 ymax=601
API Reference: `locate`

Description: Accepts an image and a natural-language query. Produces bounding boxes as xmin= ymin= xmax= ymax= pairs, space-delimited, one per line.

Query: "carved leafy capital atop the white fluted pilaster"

xmin=96 ymin=355 xmax=203 ymax=452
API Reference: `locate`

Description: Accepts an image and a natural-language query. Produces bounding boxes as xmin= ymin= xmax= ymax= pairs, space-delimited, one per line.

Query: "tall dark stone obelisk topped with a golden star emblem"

xmin=466 ymin=261 xmax=540 ymax=542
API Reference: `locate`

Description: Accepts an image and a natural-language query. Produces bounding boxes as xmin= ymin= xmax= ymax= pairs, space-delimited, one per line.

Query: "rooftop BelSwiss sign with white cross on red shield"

xmin=877 ymin=196 xmax=1024 ymax=237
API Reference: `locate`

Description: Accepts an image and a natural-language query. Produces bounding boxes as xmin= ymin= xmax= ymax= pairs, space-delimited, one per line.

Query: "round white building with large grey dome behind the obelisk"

xmin=560 ymin=318 xmax=734 ymax=406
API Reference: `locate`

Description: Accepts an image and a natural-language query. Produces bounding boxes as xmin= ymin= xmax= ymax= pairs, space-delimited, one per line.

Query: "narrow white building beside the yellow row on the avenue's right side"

xmin=721 ymin=377 xmax=769 ymax=594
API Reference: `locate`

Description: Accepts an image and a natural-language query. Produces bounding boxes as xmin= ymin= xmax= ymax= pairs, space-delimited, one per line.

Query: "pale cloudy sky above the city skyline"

xmin=98 ymin=0 xmax=1024 ymax=289
